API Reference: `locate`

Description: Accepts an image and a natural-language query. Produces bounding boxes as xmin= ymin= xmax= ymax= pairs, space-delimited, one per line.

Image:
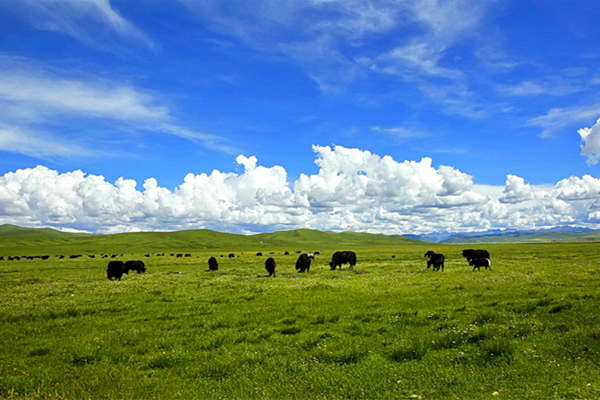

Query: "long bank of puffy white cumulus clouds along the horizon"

xmin=0 ymin=145 xmax=600 ymax=234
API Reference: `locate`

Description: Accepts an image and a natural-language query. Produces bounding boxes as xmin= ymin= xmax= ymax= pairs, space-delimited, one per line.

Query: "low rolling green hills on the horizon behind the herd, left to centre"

xmin=0 ymin=225 xmax=420 ymax=254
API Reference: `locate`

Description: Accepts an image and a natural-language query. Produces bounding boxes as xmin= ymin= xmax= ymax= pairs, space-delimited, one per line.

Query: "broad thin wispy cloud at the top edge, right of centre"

xmin=180 ymin=0 xmax=489 ymax=98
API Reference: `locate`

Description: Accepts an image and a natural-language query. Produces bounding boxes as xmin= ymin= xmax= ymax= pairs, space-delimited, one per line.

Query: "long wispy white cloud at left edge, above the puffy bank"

xmin=0 ymin=61 xmax=238 ymax=156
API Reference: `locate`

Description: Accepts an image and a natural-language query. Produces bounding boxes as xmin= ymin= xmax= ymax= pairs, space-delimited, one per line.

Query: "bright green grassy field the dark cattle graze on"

xmin=0 ymin=231 xmax=600 ymax=399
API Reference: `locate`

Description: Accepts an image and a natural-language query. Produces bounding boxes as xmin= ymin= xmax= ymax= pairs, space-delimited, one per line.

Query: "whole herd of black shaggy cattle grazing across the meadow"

xmin=0 ymin=249 xmax=492 ymax=280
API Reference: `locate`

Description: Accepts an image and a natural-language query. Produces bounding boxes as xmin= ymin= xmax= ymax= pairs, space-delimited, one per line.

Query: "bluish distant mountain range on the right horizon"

xmin=406 ymin=226 xmax=600 ymax=244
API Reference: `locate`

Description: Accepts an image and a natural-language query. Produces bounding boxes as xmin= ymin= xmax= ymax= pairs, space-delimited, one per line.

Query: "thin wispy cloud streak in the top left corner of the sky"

xmin=13 ymin=0 xmax=154 ymax=51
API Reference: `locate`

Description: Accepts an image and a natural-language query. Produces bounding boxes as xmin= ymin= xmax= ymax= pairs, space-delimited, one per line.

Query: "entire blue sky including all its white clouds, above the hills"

xmin=0 ymin=0 xmax=600 ymax=233
